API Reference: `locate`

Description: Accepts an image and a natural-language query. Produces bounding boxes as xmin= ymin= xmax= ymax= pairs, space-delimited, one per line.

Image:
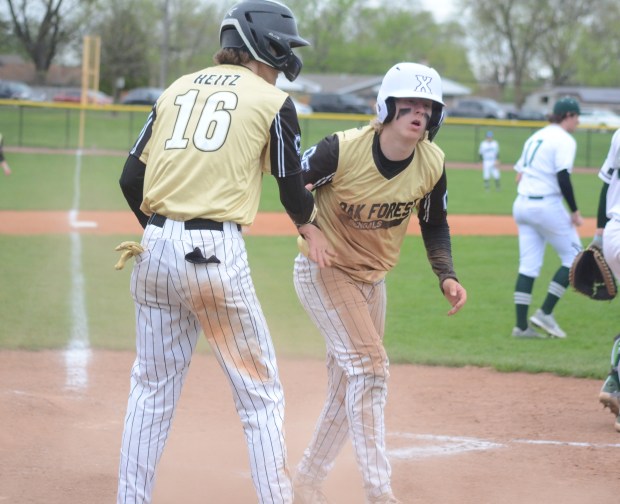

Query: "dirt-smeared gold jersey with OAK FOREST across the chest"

xmin=302 ymin=126 xmax=451 ymax=283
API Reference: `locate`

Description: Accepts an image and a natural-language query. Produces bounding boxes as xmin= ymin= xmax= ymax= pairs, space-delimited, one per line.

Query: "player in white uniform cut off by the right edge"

xmin=593 ymin=130 xmax=620 ymax=432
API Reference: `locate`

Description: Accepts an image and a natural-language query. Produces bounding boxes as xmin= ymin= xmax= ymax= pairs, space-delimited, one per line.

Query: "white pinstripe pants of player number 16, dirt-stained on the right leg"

xmin=117 ymin=220 xmax=292 ymax=504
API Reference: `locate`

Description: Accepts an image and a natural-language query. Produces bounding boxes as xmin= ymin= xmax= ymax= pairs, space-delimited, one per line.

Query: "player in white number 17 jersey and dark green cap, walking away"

xmin=512 ymin=97 xmax=583 ymax=338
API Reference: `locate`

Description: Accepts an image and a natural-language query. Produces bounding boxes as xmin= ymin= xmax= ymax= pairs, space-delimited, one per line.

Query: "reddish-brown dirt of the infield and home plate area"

xmin=0 ymin=212 xmax=620 ymax=504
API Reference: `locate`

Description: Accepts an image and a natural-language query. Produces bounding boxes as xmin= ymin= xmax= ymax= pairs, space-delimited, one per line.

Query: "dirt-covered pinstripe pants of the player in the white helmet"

xmin=294 ymin=254 xmax=391 ymax=502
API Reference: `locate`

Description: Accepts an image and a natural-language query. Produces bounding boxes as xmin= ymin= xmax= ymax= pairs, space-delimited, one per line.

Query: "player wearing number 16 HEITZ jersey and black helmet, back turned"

xmin=117 ymin=0 xmax=330 ymax=504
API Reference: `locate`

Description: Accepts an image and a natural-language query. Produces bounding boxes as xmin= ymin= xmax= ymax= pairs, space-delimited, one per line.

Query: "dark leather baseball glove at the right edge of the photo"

xmin=568 ymin=245 xmax=618 ymax=301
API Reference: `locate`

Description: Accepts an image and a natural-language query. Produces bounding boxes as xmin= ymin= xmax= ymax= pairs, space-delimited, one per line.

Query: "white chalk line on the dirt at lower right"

xmin=387 ymin=432 xmax=620 ymax=460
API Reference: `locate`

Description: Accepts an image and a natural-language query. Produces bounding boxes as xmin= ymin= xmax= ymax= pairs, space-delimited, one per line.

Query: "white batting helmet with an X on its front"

xmin=376 ymin=63 xmax=445 ymax=140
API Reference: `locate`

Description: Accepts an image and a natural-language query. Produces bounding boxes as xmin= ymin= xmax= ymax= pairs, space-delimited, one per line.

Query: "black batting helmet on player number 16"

xmin=220 ymin=0 xmax=310 ymax=81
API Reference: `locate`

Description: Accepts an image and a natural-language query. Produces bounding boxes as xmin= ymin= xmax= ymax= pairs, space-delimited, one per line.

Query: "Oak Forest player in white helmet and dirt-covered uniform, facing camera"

xmin=294 ymin=63 xmax=467 ymax=504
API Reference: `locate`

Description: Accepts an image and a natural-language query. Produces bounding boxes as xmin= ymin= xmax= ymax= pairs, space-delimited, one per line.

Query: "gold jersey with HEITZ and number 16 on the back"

xmin=130 ymin=65 xmax=301 ymax=226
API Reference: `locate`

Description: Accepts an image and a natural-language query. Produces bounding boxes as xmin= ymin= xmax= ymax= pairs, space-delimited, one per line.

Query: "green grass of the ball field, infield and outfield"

xmin=0 ymin=142 xmax=620 ymax=378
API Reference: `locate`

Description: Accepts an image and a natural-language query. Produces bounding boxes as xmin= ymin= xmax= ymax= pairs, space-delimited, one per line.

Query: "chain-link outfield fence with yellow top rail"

xmin=0 ymin=100 xmax=614 ymax=168
